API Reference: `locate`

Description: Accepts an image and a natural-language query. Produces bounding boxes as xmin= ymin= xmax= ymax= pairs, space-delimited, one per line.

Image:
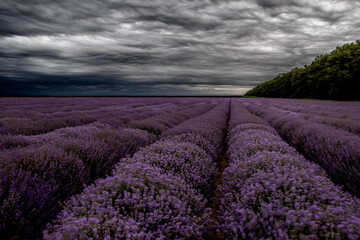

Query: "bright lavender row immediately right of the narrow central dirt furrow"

xmin=218 ymin=103 xmax=360 ymax=239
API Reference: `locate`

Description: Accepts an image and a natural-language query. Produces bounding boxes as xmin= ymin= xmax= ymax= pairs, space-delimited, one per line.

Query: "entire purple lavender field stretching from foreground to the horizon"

xmin=0 ymin=98 xmax=360 ymax=239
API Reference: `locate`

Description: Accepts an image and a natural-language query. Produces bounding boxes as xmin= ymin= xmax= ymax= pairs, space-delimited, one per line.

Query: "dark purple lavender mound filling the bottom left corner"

xmin=0 ymin=145 xmax=89 ymax=239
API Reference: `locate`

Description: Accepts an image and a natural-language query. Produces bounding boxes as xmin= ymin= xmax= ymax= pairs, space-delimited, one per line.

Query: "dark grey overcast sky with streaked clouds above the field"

xmin=0 ymin=0 xmax=360 ymax=96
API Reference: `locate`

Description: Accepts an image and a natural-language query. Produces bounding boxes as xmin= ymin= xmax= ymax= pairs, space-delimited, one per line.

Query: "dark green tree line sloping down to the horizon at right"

xmin=245 ymin=40 xmax=360 ymax=100
